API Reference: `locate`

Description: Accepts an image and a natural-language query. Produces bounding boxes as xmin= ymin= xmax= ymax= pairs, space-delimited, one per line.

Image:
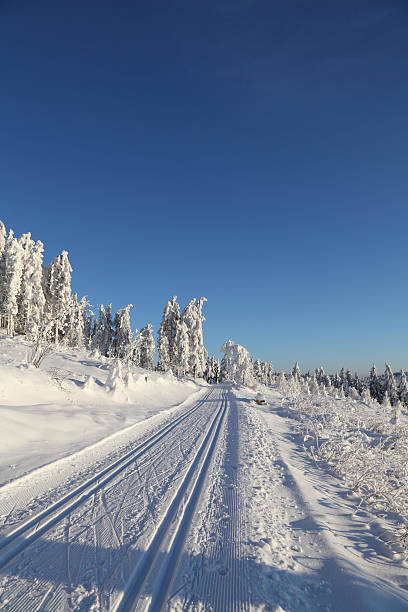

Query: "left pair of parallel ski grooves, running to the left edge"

xmin=0 ymin=390 xmax=218 ymax=570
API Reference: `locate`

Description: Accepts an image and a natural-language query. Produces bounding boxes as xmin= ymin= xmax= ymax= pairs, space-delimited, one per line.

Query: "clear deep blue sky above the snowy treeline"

xmin=0 ymin=0 xmax=408 ymax=372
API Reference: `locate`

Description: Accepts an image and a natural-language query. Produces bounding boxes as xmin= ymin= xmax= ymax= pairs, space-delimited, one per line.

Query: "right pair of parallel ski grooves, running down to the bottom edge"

xmin=114 ymin=392 xmax=228 ymax=612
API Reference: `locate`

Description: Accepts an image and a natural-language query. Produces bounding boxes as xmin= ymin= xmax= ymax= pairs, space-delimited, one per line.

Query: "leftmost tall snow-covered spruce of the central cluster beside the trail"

xmin=157 ymin=295 xmax=180 ymax=372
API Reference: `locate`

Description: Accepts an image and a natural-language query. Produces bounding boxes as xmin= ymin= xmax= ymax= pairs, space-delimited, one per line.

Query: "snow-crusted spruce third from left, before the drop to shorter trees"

xmin=43 ymin=251 xmax=72 ymax=343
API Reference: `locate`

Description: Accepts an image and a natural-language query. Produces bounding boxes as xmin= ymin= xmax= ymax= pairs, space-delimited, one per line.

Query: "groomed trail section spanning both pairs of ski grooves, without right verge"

xmin=0 ymin=389 xmax=226 ymax=612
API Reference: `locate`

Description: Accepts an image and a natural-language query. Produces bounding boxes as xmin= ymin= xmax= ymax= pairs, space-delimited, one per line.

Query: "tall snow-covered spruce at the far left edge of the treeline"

xmin=0 ymin=230 xmax=24 ymax=336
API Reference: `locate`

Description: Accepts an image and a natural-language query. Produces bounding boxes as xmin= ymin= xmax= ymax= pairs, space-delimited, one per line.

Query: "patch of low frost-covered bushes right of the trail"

xmin=280 ymin=378 xmax=408 ymax=552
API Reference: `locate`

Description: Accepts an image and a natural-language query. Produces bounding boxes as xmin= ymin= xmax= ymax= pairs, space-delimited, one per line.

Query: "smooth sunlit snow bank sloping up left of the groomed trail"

xmin=0 ymin=336 xmax=206 ymax=485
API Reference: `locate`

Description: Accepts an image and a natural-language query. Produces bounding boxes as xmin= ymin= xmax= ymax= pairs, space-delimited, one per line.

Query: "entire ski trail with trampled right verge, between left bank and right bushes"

xmin=0 ymin=385 xmax=408 ymax=612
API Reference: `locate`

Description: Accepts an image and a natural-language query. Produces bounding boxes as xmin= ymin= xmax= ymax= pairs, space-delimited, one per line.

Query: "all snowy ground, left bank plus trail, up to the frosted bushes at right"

xmin=0 ymin=338 xmax=408 ymax=612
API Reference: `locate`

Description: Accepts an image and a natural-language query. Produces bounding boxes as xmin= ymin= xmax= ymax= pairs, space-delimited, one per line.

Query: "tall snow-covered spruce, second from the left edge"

xmin=18 ymin=233 xmax=45 ymax=340
